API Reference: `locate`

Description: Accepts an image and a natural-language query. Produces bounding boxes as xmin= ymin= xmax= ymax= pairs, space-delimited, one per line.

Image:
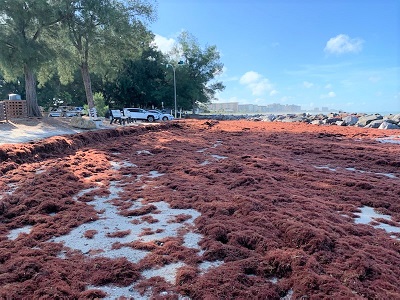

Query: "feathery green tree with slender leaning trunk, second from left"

xmin=58 ymin=0 xmax=154 ymax=111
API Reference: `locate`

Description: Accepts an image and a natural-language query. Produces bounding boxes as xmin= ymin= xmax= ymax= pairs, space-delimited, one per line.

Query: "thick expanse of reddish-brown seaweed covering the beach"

xmin=0 ymin=120 xmax=400 ymax=299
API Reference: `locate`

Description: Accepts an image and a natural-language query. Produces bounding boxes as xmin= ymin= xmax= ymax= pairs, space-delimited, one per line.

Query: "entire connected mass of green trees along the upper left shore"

xmin=0 ymin=0 xmax=224 ymax=115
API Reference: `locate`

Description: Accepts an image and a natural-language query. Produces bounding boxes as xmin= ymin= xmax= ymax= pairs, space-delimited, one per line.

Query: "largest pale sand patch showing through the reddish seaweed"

xmin=51 ymin=182 xmax=200 ymax=263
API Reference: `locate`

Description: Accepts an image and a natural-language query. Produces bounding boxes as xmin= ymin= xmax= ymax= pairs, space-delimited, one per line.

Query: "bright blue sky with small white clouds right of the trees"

xmin=150 ymin=0 xmax=400 ymax=113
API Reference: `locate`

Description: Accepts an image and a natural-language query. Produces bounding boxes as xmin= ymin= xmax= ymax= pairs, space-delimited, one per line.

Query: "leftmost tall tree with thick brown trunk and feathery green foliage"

xmin=0 ymin=0 xmax=68 ymax=116
